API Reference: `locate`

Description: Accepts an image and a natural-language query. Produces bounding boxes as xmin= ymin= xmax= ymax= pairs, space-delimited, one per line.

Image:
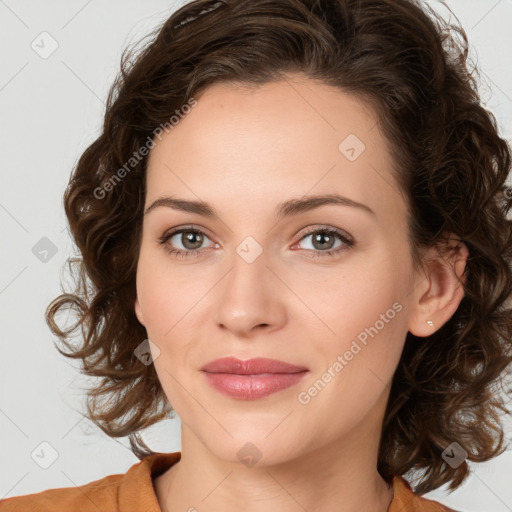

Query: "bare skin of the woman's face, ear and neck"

xmin=135 ymin=75 xmax=468 ymax=512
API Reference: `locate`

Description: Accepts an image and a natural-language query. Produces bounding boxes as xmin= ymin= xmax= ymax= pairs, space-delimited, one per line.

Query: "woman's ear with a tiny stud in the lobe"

xmin=409 ymin=233 xmax=469 ymax=337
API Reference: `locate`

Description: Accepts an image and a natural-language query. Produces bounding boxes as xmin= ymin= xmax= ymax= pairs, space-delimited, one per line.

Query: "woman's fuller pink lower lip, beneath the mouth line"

xmin=204 ymin=371 xmax=307 ymax=400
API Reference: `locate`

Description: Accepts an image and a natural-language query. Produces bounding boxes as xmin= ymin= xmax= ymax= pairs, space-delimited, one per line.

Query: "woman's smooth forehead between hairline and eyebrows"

xmin=146 ymin=77 xmax=402 ymax=222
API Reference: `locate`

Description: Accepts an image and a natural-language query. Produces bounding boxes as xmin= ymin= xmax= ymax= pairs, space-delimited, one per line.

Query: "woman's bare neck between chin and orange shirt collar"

xmin=155 ymin=418 xmax=393 ymax=512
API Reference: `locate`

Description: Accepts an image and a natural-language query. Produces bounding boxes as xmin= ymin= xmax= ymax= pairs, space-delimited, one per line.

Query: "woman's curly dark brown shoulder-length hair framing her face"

xmin=46 ymin=0 xmax=512 ymax=494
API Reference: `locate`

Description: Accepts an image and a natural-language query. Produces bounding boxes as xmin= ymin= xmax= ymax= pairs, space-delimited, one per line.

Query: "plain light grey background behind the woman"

xmin=0 ymin=0 xmax=512 ymax=512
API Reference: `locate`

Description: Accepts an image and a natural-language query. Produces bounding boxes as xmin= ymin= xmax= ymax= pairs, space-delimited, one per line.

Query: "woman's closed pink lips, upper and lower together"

xmin=201 ymin=357 xmax=308 ymax=400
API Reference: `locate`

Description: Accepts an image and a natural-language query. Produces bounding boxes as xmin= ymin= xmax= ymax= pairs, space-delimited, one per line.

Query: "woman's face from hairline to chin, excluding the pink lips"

xmin=135 ymin=75 xmax=419 ymax=464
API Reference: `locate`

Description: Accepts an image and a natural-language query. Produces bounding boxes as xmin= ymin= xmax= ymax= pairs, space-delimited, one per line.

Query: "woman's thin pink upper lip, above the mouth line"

xmin=201 ymin=357 xmax=307 ymax=375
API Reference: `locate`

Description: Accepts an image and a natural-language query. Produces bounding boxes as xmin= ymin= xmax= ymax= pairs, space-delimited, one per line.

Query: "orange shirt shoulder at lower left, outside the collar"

xmin=0 ymin=474 xmax=124 ymax=512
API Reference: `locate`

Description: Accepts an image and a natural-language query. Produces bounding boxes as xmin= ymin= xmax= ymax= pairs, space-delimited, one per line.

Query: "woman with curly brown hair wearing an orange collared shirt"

xmin=0 ymin=0 xmax=512 ymax=512
